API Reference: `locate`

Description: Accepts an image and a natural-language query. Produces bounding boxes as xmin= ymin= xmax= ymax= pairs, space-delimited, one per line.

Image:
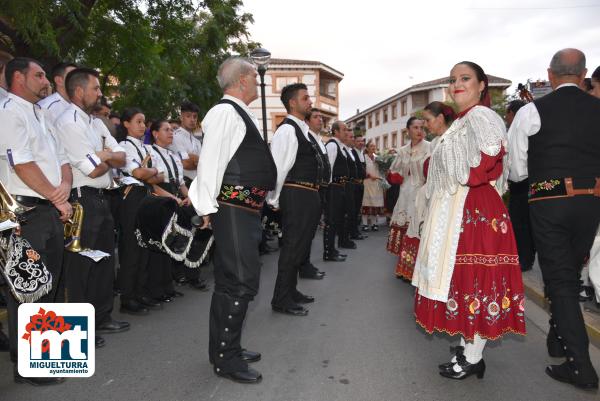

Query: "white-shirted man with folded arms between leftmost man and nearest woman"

xmin=55 ymin=68 xmax=129 ymax=347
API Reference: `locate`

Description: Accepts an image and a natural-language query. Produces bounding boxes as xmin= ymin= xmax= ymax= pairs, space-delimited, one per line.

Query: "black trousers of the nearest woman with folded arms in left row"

xmin=117 ymin=186 xmax=149 ymax=302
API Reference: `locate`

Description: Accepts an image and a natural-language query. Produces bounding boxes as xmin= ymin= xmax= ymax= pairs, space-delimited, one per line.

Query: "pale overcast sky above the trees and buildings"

xmin=242 ymin=0 xmax=600 ymax=119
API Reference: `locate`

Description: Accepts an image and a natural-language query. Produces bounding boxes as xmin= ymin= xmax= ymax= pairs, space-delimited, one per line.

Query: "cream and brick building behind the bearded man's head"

xmin=250 ymin=59 xmax=344 ymax=139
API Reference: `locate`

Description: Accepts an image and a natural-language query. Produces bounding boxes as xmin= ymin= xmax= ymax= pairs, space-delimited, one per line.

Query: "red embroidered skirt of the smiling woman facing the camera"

xmin=415 ymin=185 xmax=526 ymax=340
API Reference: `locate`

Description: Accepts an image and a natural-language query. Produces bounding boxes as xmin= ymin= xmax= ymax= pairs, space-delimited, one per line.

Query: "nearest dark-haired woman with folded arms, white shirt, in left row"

xmin=117 ymin=107 xmax=163 ymax=315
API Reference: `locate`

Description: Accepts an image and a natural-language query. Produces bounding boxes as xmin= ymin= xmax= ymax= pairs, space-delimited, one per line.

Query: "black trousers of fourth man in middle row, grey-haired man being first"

xmin=323 ymin=183 xmax=346 ymax=256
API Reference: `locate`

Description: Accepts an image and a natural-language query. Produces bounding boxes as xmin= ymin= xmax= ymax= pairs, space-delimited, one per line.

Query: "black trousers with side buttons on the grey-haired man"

xmin=208 ymin=204 xmax=262 ymax=373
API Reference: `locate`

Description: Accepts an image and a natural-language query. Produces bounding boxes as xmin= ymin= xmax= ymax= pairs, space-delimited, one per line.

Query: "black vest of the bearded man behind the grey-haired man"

xmin=282 ymin=118 xmax=323 ymax=184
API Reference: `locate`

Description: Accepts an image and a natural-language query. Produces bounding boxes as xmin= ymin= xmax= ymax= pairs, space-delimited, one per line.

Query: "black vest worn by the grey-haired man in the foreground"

xmin=217 ymin=99 xmax=277 ymax=190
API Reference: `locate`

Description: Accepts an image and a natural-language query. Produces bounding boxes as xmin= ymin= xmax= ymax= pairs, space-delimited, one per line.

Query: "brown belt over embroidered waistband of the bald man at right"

xmin=529 ymin=177 xmax=600 ymax=202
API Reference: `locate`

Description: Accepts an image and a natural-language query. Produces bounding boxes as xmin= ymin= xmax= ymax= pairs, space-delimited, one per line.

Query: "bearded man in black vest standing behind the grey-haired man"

xmin=267 ymin=83 xmax=323 ymax=316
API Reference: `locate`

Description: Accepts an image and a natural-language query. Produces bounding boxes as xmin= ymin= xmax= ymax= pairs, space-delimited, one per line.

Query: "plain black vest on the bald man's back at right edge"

xmin=527 ymin=86 xmax=600 ymax=183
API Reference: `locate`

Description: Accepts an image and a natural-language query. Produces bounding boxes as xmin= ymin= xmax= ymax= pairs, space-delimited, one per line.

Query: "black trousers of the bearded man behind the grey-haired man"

xmin=271 ymin=185 xmax=321 ymax=308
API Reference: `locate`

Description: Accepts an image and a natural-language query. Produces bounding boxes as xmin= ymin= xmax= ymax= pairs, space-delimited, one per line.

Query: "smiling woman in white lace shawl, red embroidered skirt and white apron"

xmin=412 ymin=61 xmax=525 ymax=379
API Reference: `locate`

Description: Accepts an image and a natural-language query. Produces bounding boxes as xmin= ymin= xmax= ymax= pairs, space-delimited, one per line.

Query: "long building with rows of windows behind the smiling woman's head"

xmin=345 ymin=75 xmax=511 ymax=150
